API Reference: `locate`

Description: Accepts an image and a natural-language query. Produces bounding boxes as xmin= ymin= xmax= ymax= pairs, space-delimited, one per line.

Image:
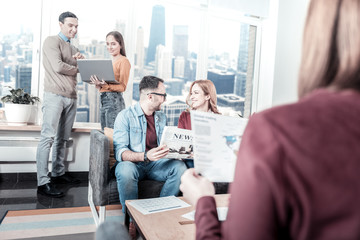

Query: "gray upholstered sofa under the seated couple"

xmin=88 ymin=130 xmax=228 ymax=226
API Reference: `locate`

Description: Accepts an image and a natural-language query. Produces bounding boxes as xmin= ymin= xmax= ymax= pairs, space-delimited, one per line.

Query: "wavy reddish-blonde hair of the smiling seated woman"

xmin=186 ymin=79 xmax=221 ymax=114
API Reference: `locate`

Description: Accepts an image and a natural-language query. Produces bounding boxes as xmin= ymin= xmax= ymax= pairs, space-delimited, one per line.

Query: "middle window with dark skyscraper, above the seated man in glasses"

xmin=133 ymin=1 xmax=200 ymax=125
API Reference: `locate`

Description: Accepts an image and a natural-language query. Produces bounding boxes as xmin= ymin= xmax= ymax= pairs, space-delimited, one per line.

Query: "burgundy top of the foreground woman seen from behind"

xmin=195 ymin=90 xmax=360 ymax=240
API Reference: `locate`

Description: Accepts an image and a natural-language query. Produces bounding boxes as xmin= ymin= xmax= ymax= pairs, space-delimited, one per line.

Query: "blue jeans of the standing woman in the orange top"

xmin=100 ymin=92 xmax=125 ymax=130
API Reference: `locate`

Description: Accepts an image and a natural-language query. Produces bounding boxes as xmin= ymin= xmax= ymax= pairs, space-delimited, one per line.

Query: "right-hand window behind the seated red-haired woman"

xmin=207 ymin=17 xmax=257 ymax=117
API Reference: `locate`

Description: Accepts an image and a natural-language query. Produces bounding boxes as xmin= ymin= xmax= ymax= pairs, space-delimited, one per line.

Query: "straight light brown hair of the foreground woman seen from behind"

xmin=298 ymin=0 xmax=360 ymax=97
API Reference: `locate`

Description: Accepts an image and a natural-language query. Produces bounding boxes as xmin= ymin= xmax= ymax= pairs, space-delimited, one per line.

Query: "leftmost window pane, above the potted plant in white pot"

xmin=0 ymin=0 xmax=41 ymax=107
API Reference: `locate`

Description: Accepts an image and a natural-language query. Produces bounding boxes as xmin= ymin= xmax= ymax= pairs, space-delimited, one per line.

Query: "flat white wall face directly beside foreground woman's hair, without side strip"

xmin=272 ymin=0 xmax=309 ymax=106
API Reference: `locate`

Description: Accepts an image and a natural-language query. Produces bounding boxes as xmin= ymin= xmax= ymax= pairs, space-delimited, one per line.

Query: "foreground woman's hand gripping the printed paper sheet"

xmin=180 ymin=168 xmax=215 ymax=206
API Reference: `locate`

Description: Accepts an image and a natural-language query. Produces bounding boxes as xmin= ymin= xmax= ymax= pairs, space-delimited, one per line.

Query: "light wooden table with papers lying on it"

xmin=125 ymin=194 xmax=229 ymax=240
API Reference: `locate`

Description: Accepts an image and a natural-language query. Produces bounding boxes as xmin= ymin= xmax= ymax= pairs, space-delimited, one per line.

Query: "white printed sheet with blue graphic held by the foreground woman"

xmin=190 ymin=111 xmax=248 ymax=182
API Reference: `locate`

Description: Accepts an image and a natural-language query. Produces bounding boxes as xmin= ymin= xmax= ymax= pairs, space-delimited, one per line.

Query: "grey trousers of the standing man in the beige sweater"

xmin=36 ymin=92 xmax=76 ymax=186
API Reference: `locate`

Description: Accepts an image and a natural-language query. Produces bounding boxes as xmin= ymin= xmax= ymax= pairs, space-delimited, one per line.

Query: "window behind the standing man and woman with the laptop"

xmin=44 ymin=0 xmax=129 ymax=122
